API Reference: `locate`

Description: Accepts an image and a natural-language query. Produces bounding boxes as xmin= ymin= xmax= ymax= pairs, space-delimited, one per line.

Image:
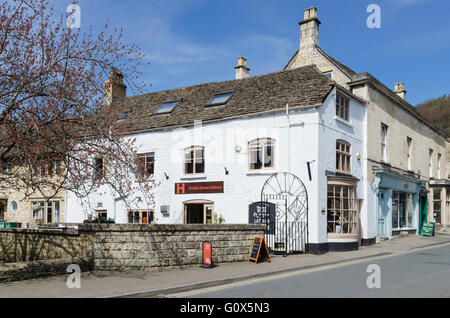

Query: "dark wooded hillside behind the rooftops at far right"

xmin=417 ymin=95 xmax=450 ymax=136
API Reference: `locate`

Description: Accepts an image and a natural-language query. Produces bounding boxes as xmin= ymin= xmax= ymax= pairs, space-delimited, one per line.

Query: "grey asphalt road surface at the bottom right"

xmin=169 ymin=246 xmax=450 ymax=299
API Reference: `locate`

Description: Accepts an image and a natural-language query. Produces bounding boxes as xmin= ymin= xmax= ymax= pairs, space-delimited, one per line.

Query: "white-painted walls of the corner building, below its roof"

xmin=64 ymin=90 xmax=365 ymax=251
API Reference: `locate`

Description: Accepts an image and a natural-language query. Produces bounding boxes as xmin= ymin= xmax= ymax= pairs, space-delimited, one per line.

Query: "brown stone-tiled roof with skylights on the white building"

xmin=121 ymin=65 xmax=335 ymax=132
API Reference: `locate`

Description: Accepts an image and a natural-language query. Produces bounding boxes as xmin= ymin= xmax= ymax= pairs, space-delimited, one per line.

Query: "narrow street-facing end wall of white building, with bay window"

xmin=318 ymin=89 xmax=373 ymax=248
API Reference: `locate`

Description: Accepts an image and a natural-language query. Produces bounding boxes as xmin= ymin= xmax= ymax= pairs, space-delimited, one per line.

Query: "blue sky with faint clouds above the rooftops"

xmin=51 ymin=0 xmax=450 ymax=105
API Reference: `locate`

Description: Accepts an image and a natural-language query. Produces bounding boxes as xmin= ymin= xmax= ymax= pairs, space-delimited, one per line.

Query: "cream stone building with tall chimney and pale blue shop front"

xmin=285 ymin=7 xmax=450 ymax=238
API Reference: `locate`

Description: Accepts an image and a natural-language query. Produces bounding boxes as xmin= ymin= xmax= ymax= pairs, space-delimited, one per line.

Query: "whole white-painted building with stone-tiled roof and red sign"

xmin=66 ymin=63 xmax=372 ymax=253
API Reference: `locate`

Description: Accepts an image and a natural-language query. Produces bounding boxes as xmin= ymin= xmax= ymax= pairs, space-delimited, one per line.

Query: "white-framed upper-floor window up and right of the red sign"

xmin=248 ymin=138 xmax=275 ymax=171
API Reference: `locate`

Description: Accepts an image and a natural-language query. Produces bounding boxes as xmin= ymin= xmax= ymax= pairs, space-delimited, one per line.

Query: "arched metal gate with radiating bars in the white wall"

xmin=261 ymin=172 xmax=309 ymax=255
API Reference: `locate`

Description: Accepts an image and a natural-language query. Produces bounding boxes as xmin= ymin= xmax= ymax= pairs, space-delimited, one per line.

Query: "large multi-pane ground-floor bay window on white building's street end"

xmin=328 ymin=184 xmax=358 ymax=234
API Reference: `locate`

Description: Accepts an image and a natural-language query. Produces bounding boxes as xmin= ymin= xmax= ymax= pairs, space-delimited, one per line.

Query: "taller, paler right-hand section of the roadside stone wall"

xmin=84 ymin=225 xmax=265 ymax=271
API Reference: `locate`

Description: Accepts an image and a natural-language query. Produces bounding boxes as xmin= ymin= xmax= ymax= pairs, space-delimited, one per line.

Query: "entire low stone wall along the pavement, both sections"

xmin=0 ymin=224 xmax=265 ymax=277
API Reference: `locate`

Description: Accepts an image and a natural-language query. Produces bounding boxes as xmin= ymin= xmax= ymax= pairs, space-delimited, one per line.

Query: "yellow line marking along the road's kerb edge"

xmin=165 ymin=242 xmax=450 ymax=298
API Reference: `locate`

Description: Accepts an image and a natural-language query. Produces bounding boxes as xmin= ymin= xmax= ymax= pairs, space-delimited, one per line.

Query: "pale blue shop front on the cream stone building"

xmin=372 ymin=168 xmax=427 ymax=237
